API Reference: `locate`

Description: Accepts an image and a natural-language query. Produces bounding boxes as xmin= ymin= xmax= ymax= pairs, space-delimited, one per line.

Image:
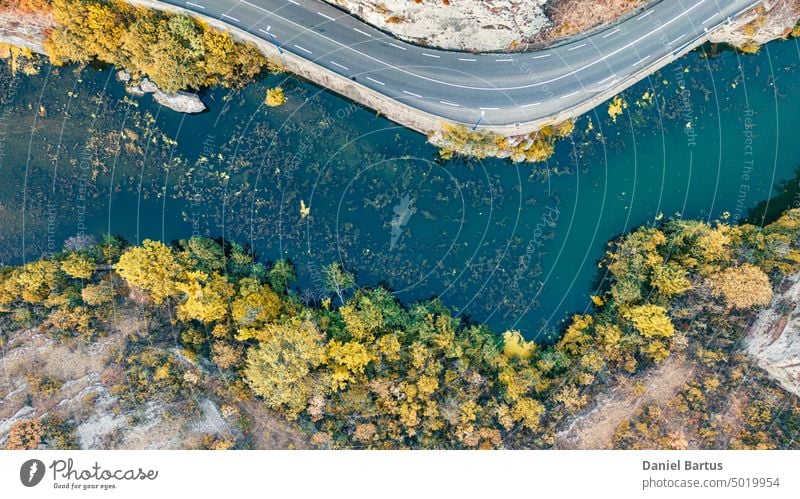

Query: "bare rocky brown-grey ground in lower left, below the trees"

xmin=0 ymin=310 xmax=308 ymax=449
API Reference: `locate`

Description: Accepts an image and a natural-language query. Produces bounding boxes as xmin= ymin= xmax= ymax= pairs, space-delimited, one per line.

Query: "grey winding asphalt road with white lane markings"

xmin=163 ymin=0 xmax=761 ymax=129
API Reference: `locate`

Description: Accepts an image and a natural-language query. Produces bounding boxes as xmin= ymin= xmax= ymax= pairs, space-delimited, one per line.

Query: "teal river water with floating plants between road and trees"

xmin=0 ymin=41 xmax=800 ymax=341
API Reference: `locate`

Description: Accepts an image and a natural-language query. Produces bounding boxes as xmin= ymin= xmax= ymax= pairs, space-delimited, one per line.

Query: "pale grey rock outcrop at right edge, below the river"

xmin=746 ymin=274 xmax=800 ymax=396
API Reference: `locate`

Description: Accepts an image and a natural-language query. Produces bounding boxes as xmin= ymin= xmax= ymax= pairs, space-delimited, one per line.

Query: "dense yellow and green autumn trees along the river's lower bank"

xmin=0 ymin=210 xmax=800 ymax=448
